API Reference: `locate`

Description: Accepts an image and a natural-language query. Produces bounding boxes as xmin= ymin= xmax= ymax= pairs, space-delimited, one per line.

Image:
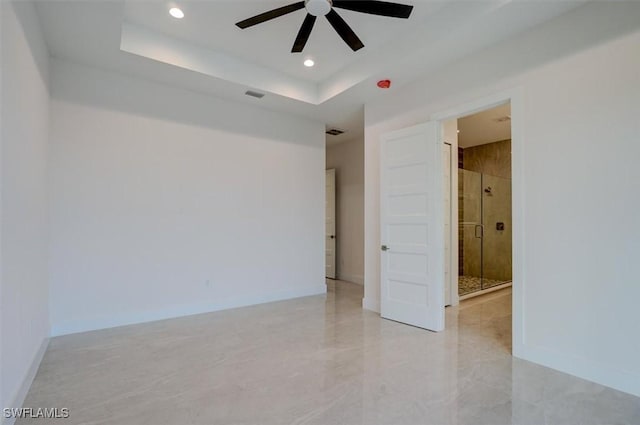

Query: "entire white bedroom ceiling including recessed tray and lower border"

xmin=33 ymin=0 xmax=583 ymax=142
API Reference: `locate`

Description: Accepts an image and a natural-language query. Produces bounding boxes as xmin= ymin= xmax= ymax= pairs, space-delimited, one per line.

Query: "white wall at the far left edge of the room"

xmin=0 ymin=2 xmax=49 ymax=420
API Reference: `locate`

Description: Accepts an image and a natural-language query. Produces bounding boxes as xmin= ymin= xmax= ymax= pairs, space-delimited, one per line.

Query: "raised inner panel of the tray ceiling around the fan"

xmin=124 ymin=0 xmax=443 ymax=83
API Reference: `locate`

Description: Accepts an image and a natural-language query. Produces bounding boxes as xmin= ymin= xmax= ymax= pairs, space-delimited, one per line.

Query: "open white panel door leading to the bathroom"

xmin=380 ymin=122 xmax=444 ymax=331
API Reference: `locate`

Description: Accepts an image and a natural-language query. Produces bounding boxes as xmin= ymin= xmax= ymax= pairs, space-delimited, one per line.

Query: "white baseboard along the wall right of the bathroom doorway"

xmin=513 ymin=344 xmax=640 ymax=397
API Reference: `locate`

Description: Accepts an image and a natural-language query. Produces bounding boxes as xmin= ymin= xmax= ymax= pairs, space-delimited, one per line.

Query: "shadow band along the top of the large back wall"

xmin=51 ymin=59 xmax=324 ymax=149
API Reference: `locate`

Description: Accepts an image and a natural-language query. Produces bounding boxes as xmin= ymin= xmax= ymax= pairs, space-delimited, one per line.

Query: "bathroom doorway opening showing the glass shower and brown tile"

xmin=453 ymin=103 xmax=513 ymax=300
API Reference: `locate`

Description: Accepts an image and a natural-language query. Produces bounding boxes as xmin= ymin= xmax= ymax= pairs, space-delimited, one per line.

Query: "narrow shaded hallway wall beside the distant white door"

xmin=327 ymin=138 xmax=364 ymax=284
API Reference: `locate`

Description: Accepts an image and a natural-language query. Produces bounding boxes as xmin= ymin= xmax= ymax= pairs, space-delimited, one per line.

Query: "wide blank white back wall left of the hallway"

xmin=50 ymin=60 xmax=326 ymax=335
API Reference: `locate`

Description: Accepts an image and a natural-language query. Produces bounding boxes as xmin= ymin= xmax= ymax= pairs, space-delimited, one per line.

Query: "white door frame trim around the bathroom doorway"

xmin=429 ymin=87 xmax=526 ymax=357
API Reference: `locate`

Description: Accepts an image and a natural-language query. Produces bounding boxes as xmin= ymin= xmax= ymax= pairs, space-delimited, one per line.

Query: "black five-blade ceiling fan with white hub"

xmin=236 ymin=0 xmax=413 ymax=53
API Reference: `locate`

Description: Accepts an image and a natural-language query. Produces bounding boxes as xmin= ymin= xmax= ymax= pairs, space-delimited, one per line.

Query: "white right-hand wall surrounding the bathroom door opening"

xmin=363 ymin=3 xmax=640 ymax=395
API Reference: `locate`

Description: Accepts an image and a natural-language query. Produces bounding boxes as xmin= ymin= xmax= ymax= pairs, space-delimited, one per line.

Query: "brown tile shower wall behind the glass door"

xmin=458 ymin=140 xmax=512 ymax=286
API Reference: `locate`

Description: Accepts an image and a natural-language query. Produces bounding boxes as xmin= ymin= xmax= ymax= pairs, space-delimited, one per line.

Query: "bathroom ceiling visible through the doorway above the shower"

xmin=458 ymin=103 xmax=511 ymax=148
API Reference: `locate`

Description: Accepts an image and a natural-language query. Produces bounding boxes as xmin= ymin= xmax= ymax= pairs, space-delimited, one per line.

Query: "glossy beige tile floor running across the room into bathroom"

xmin=17 ymin=282 xmax=640 ymax=425
